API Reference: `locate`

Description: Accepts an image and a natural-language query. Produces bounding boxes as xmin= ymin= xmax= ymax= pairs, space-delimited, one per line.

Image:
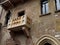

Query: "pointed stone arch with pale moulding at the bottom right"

xmin=36 ymin=34 xmax=60 ymax=45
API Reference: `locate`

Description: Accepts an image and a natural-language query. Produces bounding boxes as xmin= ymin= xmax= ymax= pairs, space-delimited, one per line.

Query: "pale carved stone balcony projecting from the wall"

xmin=7 ymin=15 xmax=32 ymax=31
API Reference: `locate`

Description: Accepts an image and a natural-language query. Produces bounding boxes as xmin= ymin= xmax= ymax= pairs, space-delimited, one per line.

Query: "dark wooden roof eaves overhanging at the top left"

xmin=0 ymin=0 xmax=27 ymax=10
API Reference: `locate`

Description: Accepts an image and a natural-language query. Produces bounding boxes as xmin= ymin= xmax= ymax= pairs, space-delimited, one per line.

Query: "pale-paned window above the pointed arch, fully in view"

xmin=41 ymin=0 xmax=49 ymax=14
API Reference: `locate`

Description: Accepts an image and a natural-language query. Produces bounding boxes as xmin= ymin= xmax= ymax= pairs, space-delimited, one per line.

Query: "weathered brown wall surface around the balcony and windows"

xmin=1 ymin=0 xmax=60 ymax=45
